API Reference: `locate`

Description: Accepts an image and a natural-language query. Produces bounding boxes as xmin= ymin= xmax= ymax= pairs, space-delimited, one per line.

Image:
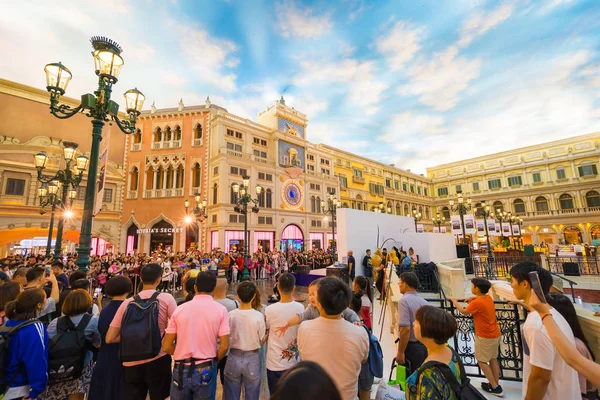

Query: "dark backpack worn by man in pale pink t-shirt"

xmin=121 ymin=292 xmax=162 ymax=362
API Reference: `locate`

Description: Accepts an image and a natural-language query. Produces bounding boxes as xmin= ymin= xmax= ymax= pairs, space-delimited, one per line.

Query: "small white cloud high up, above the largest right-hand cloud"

xmin=375 ymin=21 xmax=423 ymax=71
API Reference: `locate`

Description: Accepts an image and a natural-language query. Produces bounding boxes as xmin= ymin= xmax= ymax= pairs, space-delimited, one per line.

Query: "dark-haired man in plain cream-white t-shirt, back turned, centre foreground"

xmin=298 ymin=277 xmax=369 ymax=400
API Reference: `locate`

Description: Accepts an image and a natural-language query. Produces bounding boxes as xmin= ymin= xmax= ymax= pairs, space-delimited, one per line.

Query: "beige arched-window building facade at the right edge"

xmin=427 ymin=132 xmax=600 ymax=244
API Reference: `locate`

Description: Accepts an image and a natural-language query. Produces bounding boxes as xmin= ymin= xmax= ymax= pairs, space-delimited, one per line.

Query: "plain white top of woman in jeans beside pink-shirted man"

xmin=229 ymin=308 xmax=267 ymax=351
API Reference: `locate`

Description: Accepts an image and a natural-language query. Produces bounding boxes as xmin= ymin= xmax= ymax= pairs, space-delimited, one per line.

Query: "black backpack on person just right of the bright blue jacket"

xmin=48 ymin=314 xmax=92 ymax=383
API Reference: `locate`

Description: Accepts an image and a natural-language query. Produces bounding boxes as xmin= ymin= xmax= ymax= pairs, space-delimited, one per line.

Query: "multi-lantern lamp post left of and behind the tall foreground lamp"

xmin=33 ymin=142 xmax=88 ymax=261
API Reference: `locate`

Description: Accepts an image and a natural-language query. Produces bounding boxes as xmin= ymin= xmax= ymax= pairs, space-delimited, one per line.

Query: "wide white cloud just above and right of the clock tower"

xmin=294 ymin=58 xmax=388 ymax=115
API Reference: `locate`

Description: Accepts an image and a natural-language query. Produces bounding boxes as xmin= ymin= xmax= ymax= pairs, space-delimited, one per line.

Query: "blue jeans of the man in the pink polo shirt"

xmin=171 ymin=361 xmax=217 ymax=400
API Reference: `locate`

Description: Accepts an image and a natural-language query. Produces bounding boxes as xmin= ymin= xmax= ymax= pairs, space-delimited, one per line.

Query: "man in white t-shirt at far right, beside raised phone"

xmin=510 ymin=262 xmax=581 ymax=400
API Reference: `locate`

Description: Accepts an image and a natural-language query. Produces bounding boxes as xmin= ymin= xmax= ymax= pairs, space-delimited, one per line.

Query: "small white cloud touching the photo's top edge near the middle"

xmin=276 ymin=0 xmax=332 ymax=38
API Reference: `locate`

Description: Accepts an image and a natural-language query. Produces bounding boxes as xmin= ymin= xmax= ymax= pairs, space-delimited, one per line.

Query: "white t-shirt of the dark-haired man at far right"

xmin=523 ymin=309 xmax=581 ymax=400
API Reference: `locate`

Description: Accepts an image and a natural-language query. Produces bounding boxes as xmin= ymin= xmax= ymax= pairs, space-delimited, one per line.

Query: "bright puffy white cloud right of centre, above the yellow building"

xmin=398 ymin=46 xmax=481 ymax=111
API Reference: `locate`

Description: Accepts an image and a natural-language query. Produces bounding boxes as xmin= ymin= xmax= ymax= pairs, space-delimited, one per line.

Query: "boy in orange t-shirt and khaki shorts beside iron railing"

xmin=451 ymin=278 xmax=503 ymax=397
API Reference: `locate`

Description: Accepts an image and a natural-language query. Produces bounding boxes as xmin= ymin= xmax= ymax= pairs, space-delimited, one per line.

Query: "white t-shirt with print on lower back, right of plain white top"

xmin=265 ymin=301 xmax=304 ymax=371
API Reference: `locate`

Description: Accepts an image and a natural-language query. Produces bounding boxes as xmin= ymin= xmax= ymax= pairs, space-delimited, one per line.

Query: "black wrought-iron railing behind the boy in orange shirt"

xmin=425 ymin=298 xmax=526 ymax=381
